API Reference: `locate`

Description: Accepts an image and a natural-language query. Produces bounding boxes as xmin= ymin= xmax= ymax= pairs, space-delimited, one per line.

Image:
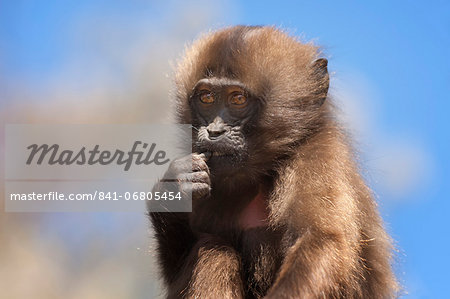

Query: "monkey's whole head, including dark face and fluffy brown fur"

xmin=176 ymin=27 xmax=329 ymax=178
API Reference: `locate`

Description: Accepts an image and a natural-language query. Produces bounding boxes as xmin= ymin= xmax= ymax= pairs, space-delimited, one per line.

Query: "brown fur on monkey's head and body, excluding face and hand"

xmin=151 ymin=26 xmax=398 ymax=298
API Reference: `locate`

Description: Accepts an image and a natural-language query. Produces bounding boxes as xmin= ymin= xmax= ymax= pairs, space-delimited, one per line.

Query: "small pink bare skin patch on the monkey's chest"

xmin=239 ymin=191 xmax=269 ymax=229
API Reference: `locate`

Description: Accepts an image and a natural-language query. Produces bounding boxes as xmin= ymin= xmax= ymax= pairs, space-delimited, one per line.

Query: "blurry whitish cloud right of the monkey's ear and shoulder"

xmin=331 ymin=71 xmax=433 ymax=200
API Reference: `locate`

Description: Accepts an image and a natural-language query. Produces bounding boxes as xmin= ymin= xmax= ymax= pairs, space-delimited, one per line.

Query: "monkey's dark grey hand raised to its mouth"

xmin=154 ymin=153 xmax=211 ymax=200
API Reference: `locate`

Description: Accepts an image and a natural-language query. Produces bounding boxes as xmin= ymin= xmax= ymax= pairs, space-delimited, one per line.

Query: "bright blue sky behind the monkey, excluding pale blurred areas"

xmin=0 ymin=0 xmax=450 ymax=298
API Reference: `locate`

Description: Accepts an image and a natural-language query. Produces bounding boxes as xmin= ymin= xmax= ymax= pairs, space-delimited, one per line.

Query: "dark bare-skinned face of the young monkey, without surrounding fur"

xmin=190 ymin=77 xmax=261 ymax=174
